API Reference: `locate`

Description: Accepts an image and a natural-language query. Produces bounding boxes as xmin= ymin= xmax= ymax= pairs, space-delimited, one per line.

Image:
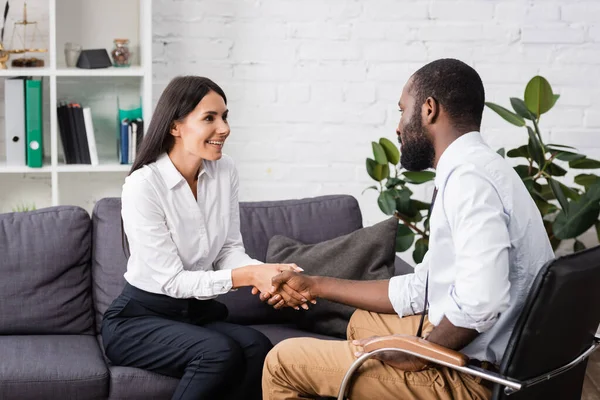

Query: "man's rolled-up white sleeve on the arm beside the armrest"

xmin=444 ymin=167 xmax=510 ymax=332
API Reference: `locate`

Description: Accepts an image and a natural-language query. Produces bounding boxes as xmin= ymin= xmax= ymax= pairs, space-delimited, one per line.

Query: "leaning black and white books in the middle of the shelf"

xmin=57 ymin=102 xmax=98 ymax=165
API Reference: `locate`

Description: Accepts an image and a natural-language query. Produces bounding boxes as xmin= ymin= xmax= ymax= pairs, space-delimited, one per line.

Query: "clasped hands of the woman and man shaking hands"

xmin=247 ymin=264 xmax=317 ymax=310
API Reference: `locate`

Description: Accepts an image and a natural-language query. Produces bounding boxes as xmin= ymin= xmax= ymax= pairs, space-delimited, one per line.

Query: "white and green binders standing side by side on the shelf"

xmin=4 ymin=77 xmax=44 ymax=168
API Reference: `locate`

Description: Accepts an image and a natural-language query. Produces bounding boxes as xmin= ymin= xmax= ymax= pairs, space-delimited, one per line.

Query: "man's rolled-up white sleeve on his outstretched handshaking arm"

xmin=388 ymin=254 xmax=429 ymax=317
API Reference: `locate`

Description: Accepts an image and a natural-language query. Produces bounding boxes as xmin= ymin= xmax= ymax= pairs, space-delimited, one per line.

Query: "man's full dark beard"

xmin=398 ymin=113 xmax=435 ymax=171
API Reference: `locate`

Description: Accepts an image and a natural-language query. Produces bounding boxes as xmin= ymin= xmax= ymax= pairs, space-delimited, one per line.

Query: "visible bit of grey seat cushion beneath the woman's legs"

xmin=108 ymin=365 xmax=179 ymax=400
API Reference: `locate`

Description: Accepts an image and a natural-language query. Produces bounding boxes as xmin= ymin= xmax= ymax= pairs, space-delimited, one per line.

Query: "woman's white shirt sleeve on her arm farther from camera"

xmin=213 ymin=161 xmax=262 ymax=274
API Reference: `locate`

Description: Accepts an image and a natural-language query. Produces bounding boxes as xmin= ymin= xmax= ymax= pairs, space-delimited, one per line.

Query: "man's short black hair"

xmin=411 ymin=58 xmax=485 ymax=130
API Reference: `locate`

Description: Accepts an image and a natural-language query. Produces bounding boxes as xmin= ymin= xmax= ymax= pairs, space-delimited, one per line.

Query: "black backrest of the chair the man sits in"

xmin=493 ymin=246 xmax=600 ymax=400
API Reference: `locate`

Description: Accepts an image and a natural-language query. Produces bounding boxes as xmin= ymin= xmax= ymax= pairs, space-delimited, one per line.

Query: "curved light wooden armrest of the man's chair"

xmin=364 ymin=335 xmax=469 ymax=367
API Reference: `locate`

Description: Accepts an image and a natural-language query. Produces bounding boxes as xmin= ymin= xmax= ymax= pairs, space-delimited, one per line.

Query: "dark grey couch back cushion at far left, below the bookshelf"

xmin=0 ymin=206 xmax=94 ymax=335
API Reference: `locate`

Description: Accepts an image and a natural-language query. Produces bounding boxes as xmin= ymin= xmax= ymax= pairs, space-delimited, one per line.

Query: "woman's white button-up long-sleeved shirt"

xmin=121 ymin=153 xmax=261 ymax=299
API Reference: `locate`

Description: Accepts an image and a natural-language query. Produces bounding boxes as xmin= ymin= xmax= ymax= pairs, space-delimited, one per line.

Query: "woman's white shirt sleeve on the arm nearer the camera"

xmin=121 ymin=178 xmax=232 ymax=299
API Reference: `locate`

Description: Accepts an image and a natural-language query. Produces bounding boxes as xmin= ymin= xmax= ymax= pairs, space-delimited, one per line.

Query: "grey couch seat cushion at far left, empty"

xmin=0 ymin=335 xmax=108 ymax=400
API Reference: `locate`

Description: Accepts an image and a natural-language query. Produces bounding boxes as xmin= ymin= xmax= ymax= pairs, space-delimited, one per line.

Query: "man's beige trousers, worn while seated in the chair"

xmin=262 ymin=310 xmax=491 ymax=400
